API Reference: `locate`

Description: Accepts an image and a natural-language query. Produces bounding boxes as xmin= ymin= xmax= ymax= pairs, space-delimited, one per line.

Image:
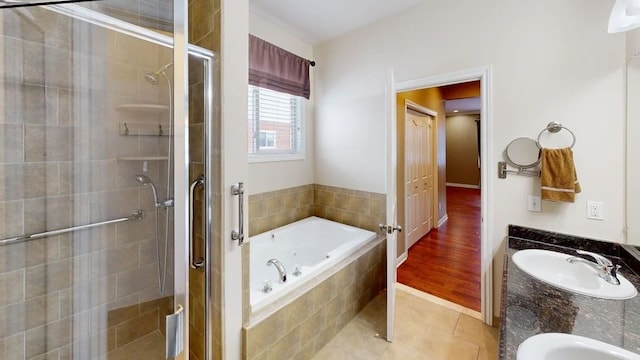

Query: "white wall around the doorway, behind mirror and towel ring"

xmin=315 ymin=0 xmax=625 ymax=315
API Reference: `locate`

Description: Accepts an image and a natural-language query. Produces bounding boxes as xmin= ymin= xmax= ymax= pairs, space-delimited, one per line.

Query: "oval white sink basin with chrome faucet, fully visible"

xmin=512 ymin=249 xmax=638 ymax=300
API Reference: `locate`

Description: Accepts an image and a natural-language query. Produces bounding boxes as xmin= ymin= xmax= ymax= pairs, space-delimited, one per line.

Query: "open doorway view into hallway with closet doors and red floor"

xmin=398 ymin=80 xmax=481 ymax=317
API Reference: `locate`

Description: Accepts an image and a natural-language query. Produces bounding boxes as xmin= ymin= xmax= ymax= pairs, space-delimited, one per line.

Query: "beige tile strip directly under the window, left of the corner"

xmin=249 ymin=185 xmax=313 ymax=236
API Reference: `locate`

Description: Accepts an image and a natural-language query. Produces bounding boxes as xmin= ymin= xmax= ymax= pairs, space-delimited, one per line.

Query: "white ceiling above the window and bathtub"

xmin=250 ymin=0 xmax=424 ymax=44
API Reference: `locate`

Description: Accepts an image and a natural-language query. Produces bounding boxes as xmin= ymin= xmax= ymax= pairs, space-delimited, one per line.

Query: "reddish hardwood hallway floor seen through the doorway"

xmin=398 ymin=186 xmax=480 ymax=311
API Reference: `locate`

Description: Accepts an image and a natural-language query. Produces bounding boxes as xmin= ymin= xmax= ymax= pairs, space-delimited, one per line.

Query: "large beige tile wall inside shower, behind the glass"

xmin=0 ymin=7 xmax=171 ymax=359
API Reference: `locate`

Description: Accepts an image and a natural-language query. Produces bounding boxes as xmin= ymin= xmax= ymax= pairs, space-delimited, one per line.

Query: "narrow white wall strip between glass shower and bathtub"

xmin=219 ymin=0 xmax=250 ymax=359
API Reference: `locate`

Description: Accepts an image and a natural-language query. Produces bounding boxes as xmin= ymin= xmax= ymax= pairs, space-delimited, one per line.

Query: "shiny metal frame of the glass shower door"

xmin=33 ymin=0 xmax=215 ymax=359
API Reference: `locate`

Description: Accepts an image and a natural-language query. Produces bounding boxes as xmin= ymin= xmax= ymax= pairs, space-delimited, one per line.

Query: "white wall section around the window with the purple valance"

xmin=245 ymin=9 xmax=315 ymax=194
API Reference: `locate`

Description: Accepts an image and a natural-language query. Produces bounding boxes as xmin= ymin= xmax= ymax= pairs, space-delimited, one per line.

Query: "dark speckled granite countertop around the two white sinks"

xmin=499 ymin=225 xmax=640 ymax=360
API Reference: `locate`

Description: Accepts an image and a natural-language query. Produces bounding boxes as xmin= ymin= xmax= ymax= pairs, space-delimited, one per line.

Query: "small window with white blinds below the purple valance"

xmin=248 ymin=85 xmax=304 ymax=161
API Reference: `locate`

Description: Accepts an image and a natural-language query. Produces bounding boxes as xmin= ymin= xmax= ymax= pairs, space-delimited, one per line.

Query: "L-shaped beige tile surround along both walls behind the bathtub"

xmin=249 ymin=184 xmax=386 ymax=236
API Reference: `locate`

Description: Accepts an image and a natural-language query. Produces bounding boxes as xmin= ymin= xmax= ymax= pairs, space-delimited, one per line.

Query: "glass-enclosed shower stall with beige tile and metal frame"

xmin=0 ymin=0 xmax=221 ymax=360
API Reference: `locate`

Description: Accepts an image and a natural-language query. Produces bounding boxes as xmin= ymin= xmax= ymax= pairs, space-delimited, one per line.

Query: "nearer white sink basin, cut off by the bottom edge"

xmin=516 ymin=333 xmax=640 ymax=360
